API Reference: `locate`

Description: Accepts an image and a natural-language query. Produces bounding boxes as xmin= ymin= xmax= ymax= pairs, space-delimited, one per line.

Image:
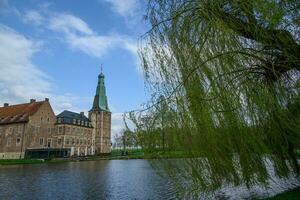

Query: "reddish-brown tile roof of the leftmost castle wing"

xmin=0 ymin=101 xmax=45 ymax=125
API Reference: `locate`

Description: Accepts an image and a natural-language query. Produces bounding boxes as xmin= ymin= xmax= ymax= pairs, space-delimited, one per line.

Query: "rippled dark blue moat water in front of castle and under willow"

xmin=0 ymin=160 xmax=300 ymax=200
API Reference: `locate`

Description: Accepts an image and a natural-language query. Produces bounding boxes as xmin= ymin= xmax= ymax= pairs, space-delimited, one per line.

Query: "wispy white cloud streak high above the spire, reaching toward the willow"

xmin=49 ymin=14 xmax=137 ymax=58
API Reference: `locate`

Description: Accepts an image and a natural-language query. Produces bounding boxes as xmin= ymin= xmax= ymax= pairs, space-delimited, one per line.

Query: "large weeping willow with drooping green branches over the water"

xmin=127 ymin=0 xmax=300 ymax=197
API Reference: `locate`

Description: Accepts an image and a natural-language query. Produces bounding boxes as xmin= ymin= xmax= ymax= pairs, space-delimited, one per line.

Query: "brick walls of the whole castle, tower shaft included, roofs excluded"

xmin=0 ymin=101 xmax=106 ymax=159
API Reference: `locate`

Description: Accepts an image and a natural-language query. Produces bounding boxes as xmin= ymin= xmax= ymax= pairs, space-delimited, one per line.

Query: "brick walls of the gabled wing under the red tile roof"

xmin=0 ymin=101 xmax=56 ymax=159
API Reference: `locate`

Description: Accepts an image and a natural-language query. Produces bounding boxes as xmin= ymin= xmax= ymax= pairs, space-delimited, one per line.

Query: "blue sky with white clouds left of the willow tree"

xmin=0 ymin=0 xmax=148 ymax=137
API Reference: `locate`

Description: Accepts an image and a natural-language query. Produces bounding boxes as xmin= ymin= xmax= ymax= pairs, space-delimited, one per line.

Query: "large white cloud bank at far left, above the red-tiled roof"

xmin=0 ymin=24 xmax=80 ymax=112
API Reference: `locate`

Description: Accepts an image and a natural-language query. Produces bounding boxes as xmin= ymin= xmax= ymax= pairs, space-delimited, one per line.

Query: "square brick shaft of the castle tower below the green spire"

xmin=90 ymin=111 xmax=111 ymax=154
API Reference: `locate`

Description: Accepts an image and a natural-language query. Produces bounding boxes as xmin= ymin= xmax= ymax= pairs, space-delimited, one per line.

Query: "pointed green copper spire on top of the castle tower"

xmin=92 ymin=67 xmax=110 ymax=112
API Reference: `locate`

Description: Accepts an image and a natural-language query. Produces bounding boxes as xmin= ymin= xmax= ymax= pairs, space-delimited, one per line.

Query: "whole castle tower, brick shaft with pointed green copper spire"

xmin=89 ymin=70 xmax=111 ymax=155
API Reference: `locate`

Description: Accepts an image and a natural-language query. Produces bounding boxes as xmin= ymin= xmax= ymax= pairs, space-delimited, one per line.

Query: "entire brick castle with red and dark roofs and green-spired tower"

xmin=0 ymin=72 xmax=111 ymax=159
